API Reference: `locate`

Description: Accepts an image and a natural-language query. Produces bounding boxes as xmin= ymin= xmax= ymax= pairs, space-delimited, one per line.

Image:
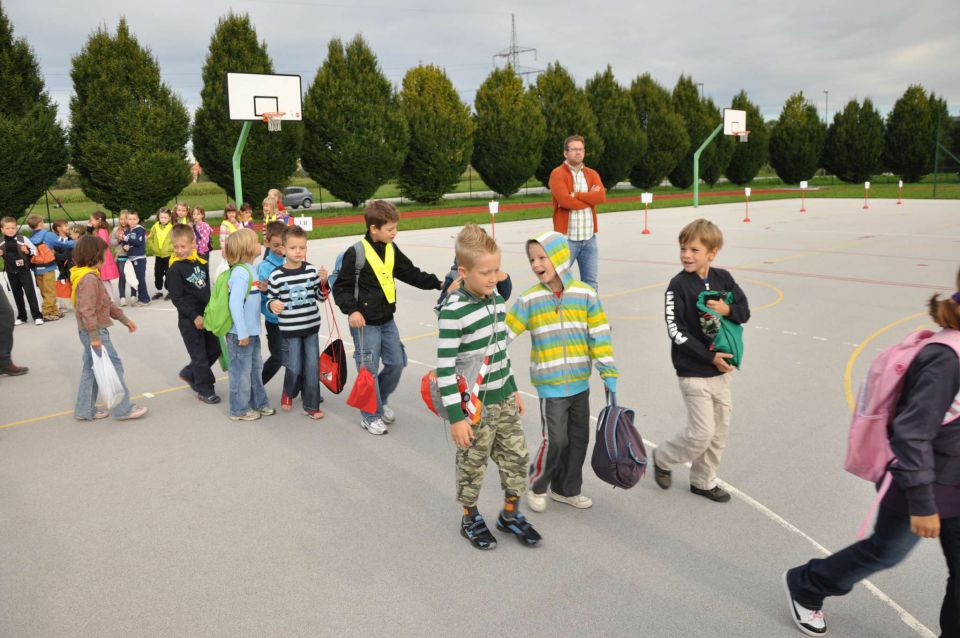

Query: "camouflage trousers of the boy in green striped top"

xmin=457 ymin=395 xmax=530 ymax=507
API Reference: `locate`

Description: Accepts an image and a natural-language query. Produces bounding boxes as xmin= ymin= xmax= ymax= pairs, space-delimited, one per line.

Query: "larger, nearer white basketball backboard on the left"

xmin=227 ymin=73 xmax=303 ymax=122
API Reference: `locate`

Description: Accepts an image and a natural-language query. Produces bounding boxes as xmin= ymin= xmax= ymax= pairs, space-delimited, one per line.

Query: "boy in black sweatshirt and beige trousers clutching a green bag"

xmin=653 ymin=219 xmax=750 ymax=503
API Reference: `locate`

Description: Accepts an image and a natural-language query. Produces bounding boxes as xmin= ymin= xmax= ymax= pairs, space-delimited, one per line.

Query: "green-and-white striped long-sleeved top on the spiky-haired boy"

xmin=437 ymin=289 xmax=517 ymax=423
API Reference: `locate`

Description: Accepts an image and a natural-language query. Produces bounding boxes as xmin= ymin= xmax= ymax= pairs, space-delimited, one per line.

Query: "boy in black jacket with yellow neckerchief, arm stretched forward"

xmin=331 ymin=200 xmax=440 ymax=435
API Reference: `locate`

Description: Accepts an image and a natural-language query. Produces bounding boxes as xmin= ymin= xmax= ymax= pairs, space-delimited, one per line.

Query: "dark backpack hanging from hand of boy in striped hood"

xmin=590 ymin=391 xmax=647 ymax=489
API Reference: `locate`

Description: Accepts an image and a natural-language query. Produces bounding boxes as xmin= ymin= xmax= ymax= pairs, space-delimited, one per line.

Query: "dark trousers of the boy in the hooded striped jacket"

xmin=530 ymin=390 xmax=590 ymax=496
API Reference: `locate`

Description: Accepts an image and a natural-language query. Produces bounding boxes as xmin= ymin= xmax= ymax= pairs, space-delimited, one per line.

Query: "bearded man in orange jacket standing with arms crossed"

xmin=550 ymin=135 xmax=607 ymax=290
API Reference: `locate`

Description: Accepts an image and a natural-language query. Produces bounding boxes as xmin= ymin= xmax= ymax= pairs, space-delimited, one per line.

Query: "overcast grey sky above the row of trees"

xmin=7 ymin=0 xmax=960 ymax=126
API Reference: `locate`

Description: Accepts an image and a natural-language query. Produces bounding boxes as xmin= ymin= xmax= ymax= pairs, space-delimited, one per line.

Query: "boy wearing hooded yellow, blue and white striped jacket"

xmin=506 ymin=231 xmax=620 ymax=512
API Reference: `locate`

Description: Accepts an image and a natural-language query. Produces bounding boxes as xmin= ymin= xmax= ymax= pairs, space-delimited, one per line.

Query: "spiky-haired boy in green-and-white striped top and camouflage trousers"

xmin=437 ymin=224 xmax=540 ymax=550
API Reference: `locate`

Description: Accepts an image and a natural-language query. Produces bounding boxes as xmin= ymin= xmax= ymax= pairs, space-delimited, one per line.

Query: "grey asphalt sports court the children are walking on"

xmin=0 ymin=199 xmax=960 ymax=638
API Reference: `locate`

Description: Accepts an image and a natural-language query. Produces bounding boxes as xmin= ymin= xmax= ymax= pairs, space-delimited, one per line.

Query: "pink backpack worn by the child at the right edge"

xmin=843 ymin=329 xmax=960 ymax=538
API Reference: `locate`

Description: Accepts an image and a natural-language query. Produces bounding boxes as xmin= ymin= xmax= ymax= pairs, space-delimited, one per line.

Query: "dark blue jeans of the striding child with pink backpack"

xmin=787 ymin=505 xmax=960 ymax=638
